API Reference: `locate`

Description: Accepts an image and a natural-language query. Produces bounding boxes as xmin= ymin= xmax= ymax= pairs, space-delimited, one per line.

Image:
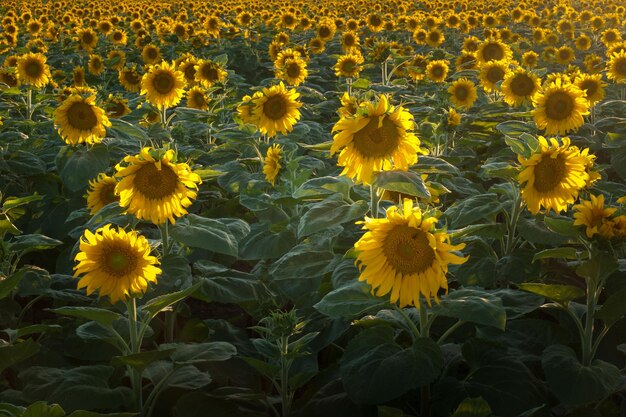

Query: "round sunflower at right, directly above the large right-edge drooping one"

xmin=533 ymin=79 xmax=589 ymax=135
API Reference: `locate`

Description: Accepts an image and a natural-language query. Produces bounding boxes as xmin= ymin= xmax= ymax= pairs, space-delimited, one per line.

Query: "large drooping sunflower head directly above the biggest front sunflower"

xmin=330 ymin=95 xmax=427 ymax=184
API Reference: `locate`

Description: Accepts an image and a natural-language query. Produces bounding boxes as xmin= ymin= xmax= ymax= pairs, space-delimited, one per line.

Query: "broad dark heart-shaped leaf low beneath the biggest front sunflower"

xmin=340 ymin=326 xmax=443 ymax=404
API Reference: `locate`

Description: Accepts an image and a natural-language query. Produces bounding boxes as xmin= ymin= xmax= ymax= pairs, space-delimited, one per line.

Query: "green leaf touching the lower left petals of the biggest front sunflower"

xmin=314 ymin=280 xmax=389 ymax=318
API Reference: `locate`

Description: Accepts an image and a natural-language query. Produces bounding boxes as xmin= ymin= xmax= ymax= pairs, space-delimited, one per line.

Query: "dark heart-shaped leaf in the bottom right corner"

xmin=541 ymin=345 xmax=620 ymax=406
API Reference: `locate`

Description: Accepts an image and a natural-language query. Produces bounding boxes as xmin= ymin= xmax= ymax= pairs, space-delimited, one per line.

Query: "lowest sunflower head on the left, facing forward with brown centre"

xmin=74 ymin=224 xmax=162 ymax=303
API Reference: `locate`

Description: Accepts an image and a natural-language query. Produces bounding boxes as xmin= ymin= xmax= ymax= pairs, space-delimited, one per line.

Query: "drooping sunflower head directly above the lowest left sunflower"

xmin=115 ymin=147 xmax=202 ymax=225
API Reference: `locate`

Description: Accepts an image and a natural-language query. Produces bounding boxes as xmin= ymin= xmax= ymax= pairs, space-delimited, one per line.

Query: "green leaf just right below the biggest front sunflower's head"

xmin=432 ymin=288 xmax=506 ymax=330
